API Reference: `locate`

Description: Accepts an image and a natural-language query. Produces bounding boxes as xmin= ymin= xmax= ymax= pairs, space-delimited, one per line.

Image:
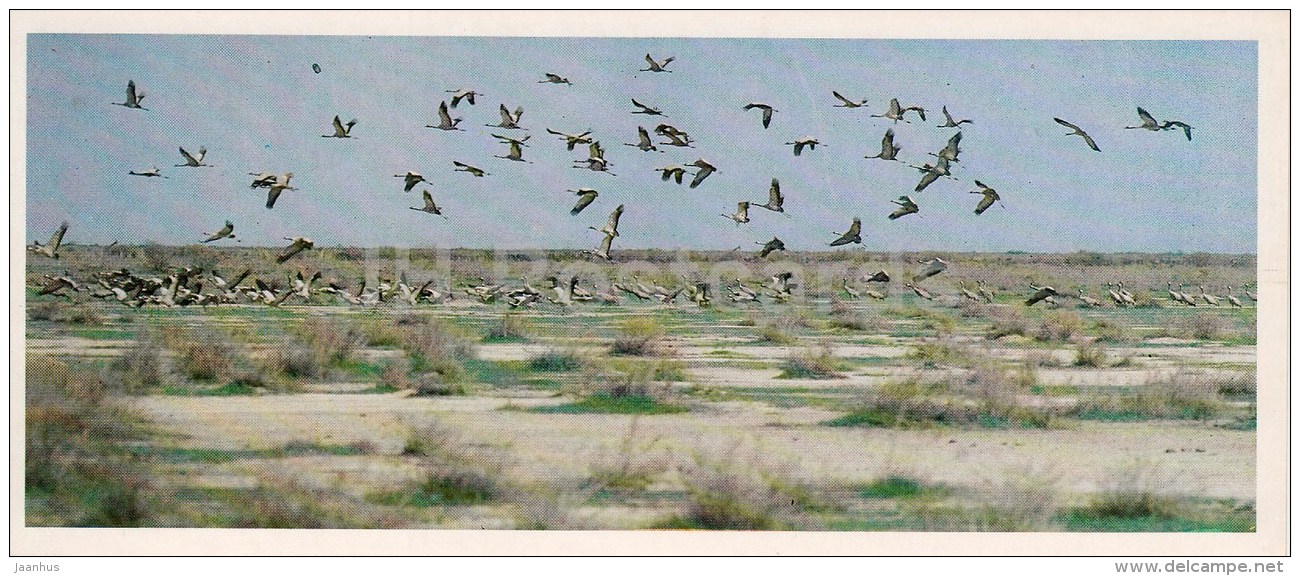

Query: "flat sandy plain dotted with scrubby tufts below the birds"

xmin=26 ymin=247 xmax=1256 ymax=532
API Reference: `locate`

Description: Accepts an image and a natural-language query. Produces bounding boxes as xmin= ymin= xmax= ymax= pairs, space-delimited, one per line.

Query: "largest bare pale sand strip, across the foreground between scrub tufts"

xmin=138 ymin=384 xmax=1256 ymax=499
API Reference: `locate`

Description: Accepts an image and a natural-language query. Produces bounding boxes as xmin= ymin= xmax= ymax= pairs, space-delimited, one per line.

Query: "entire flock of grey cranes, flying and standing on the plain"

xmin=29 ymin=53 xmax=1237 ymax=313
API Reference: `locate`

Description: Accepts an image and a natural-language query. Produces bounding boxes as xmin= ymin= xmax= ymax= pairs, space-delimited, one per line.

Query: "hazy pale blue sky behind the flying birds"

xmin=26 ymin=35 xmax=1257 ymax=254
